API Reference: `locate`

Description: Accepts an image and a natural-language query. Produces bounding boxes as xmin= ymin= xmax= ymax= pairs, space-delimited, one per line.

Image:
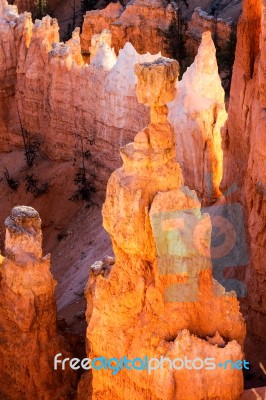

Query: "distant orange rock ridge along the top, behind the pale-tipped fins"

xmin=81 ymin=0 xmax=236 ymax=60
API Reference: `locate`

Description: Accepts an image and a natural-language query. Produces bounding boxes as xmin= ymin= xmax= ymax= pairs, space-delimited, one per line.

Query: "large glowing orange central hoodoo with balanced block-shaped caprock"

xmin=79 ymin=58 xmax=245 ymax=400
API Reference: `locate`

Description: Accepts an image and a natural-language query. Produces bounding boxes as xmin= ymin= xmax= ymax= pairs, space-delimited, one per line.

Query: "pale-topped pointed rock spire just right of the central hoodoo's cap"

xmin=169 ymin=32 xmax=227 ymax=201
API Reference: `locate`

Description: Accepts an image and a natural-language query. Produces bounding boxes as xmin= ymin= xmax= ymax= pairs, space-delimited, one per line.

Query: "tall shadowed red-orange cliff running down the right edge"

xmin=223 ymin=0 xmax=266 ymax=340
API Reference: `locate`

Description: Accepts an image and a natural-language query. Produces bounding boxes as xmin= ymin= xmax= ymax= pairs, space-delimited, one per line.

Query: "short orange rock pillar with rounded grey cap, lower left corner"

xmin=0 ymin=206 xmax=75 ymax=400
